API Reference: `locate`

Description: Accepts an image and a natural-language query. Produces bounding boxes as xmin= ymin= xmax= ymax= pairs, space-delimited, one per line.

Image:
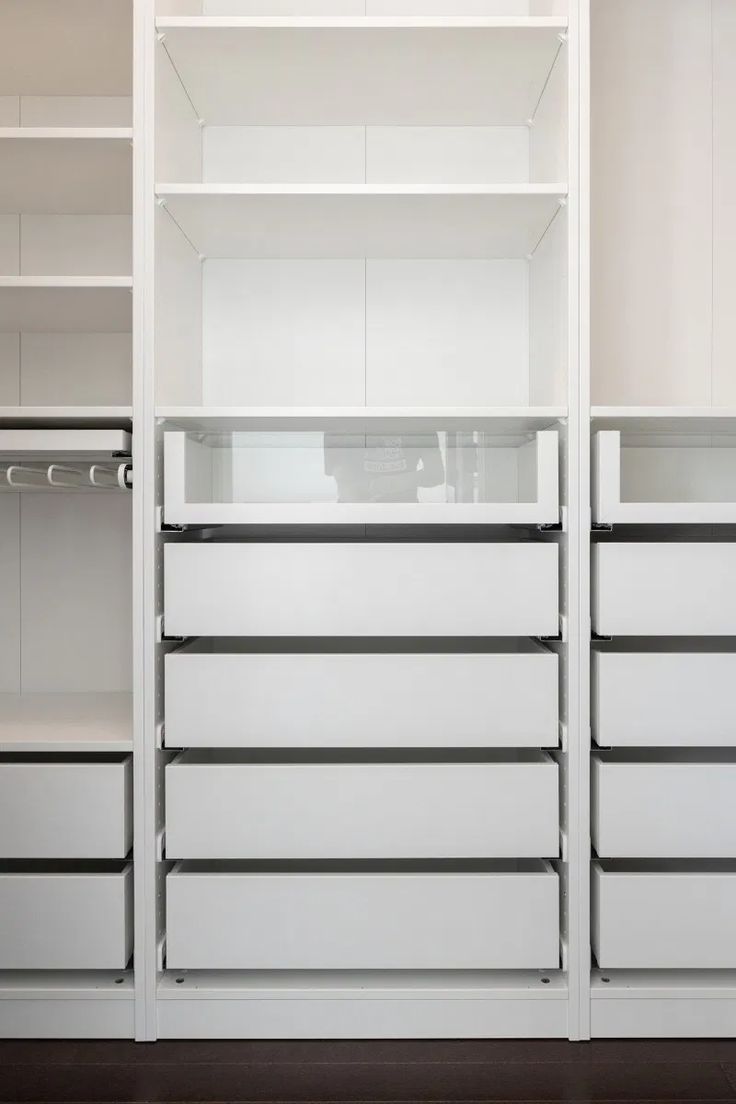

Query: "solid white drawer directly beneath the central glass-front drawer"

xmin=164 ymin=542 xmax=558 ymax=636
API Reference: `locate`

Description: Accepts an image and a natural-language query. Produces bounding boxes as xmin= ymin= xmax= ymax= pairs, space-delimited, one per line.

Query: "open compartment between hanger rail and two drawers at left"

xmin=0 ymin=487 xmax=132 ymax=737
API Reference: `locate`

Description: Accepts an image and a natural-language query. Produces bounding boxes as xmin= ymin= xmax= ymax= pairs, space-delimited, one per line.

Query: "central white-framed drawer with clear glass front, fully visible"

xmin=163 ymin=418 xmax=559 ymax=524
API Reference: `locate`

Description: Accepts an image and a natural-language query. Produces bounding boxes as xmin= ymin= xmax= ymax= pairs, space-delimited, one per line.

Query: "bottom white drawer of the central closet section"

xmin=167 ymin=860 xmax=559 ymax=969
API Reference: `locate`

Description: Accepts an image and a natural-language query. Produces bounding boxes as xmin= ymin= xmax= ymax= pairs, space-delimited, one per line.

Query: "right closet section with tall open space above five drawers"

xmin=590 ymin=0 xmax=736 ymax=1037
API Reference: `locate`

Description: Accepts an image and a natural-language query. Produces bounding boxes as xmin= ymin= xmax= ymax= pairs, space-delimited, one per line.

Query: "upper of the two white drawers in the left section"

xmin=0 ymin=755 xmax=132 ymax=859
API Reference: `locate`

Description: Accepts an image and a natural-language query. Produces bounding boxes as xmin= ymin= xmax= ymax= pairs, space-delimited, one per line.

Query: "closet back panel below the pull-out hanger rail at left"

xmin=0 ymin=491 xmax=132 ymax=693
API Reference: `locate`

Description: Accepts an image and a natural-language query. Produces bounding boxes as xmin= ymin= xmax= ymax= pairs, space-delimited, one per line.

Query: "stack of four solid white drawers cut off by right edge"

xmin=591 ymin=541 xmax=736 ymax=968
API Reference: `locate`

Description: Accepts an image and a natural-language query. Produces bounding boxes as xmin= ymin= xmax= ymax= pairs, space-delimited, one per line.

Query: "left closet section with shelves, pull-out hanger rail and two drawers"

xmin=0 ymin=0 xmax=140 ymax=1038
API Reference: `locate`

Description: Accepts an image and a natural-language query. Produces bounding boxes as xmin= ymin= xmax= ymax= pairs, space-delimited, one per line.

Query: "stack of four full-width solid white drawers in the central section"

xmin=164 ymin=541 xmax=559 ymax=969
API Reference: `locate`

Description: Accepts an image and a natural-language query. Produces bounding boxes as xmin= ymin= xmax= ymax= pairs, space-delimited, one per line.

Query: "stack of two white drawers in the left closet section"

xmin=0 ymin=755 xmax=134 ymax=970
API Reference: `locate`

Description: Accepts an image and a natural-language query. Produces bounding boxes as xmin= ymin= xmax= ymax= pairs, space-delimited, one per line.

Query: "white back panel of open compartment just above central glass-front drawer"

xmin=198 ymin=261 xmax=531 ymax=406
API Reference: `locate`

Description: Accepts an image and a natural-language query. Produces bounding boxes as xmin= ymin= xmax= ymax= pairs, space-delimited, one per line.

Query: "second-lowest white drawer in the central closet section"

xmin=166 ymin=752 xmax=559 ymax=859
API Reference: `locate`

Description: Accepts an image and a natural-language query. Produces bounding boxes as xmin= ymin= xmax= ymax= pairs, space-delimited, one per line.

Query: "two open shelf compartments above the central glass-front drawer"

xmin=156 ymin=15 xmax=568 ymax=415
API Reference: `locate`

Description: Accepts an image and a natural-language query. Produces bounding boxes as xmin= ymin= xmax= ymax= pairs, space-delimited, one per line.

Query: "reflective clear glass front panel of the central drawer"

xmin=186 ymin=429 xmax=535 ymax=503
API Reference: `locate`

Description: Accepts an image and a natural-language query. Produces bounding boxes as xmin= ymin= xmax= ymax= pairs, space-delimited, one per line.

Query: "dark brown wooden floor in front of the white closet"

xmin=0 ymin=1040 xmax=736 ymax=1104
